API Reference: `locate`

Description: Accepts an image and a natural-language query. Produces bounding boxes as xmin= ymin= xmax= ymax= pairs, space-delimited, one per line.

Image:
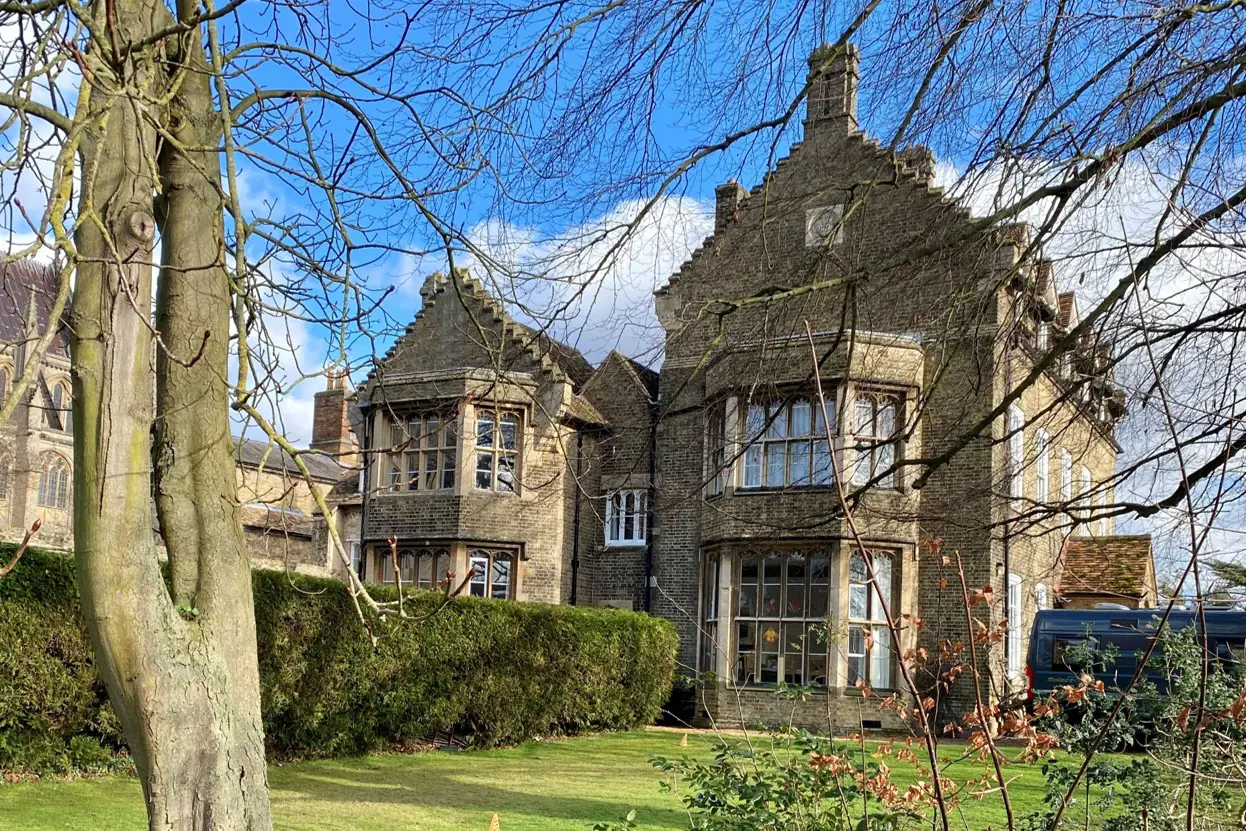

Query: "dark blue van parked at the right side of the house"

xmin=1025 ymin=609 xmax=1246 ymax=701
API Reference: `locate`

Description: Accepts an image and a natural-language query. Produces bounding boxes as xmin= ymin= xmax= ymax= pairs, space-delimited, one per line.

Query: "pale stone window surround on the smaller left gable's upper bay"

xmin=360 ymin=399 xmax=538 ymax=500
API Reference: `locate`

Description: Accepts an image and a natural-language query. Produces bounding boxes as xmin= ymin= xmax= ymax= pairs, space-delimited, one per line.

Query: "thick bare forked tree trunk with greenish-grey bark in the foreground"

xmin=72 ymin=0 xmax=272 ymax=831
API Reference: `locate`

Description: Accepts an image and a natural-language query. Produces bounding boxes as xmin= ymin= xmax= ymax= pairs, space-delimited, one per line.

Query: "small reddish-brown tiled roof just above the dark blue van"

xmin=1058 ymin=534 xmax=1155 ymax=599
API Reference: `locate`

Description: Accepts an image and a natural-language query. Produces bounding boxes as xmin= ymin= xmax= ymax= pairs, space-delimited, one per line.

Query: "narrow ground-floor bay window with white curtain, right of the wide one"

xmin=847 ymin=551 xmax=893 ymax=689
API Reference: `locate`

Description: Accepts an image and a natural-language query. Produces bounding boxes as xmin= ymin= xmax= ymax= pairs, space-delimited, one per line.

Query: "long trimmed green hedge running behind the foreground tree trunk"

xmin=0 ymin=551 xmax=677 ymax=771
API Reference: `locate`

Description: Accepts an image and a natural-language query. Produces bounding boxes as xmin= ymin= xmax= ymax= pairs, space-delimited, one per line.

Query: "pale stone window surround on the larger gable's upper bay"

xmin=704 ymin=379 xmax=918 ymax=498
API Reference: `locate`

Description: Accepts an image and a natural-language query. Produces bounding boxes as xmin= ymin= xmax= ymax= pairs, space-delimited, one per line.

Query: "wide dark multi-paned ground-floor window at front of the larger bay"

xmin=733 ymin=552 xmax=830 ymax=685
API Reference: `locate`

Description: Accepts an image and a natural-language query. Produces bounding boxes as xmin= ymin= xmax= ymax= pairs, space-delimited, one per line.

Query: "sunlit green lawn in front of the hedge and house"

xmin=0 ymin=730 xmax=1071 ymax=831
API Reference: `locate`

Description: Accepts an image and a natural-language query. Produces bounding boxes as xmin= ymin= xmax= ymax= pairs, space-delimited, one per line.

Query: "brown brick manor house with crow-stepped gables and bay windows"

xmin=343 ymin=46 xmax=1155 ymax=726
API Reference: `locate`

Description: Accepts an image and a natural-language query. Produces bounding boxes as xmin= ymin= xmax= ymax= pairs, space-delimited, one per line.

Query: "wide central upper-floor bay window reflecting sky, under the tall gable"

xmin=741 ymin=397 xmax=835 ymax=488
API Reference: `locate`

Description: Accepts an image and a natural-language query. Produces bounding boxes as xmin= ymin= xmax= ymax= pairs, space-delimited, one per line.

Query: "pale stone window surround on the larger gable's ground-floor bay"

xmin=697 ymin=539 xmax=917 ymax=695
